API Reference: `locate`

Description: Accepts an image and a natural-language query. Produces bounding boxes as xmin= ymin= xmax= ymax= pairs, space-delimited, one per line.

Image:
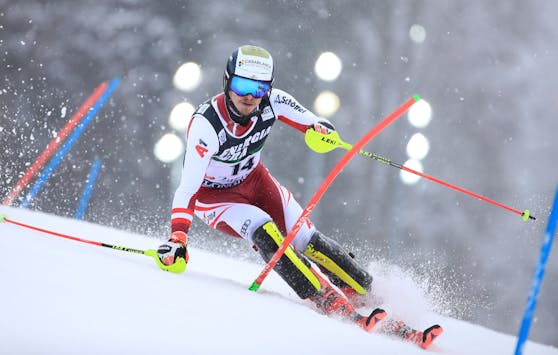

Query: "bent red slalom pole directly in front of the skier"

xmin=249 ymin=95 xmax=420 ymax=291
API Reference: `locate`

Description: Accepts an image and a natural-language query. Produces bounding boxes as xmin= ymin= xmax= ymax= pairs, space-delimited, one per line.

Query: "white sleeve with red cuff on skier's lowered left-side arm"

xmin=171 ymin=115 xmax=219 ymax=233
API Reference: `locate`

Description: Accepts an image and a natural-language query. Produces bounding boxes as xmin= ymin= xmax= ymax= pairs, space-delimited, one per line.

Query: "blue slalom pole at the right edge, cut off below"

xmin=515 ymin=189 xmax=558 ymax=355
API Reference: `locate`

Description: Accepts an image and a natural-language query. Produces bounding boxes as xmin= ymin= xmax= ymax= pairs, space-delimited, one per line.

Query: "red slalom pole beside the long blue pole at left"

xmin=2 ymin=82 xmax=108 ymax=205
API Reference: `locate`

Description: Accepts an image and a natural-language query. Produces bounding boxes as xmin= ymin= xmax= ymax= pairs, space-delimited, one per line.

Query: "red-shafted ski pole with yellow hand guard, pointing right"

xmin=305 ymin=130 xmax=536 ymax=221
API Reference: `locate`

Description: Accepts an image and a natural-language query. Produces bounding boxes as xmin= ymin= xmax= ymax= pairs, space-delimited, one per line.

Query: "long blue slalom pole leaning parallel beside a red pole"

xmin=21 ymin=78 xmax=120 ymax=208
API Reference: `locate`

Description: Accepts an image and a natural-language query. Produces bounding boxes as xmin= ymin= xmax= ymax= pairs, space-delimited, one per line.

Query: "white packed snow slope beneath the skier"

xmin=0 ymin=207 xmax=558 ymax=355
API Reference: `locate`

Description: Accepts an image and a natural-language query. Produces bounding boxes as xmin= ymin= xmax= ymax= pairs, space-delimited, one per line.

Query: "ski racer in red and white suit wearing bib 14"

xmin=158 ymin=45 xmax=444 ymax=350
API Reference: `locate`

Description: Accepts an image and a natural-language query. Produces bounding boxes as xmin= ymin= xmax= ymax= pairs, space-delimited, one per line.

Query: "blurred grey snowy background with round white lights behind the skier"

xmin=0 ymin=0 xmax=558 ymax=346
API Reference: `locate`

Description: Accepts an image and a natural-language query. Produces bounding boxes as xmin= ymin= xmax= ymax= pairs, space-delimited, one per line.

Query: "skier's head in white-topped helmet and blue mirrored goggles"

xmin=223 ymin=45 xmax=273 ymax=126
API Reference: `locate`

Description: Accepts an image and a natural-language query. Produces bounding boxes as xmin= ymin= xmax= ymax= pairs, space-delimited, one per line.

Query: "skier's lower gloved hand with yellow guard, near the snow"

xmin=157 ymin=231 xmax=190 ymax=273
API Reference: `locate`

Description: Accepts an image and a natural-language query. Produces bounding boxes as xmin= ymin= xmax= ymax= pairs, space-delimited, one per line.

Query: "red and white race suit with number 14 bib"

xmin=171 ymin=89 xmax=327 ymax=250
